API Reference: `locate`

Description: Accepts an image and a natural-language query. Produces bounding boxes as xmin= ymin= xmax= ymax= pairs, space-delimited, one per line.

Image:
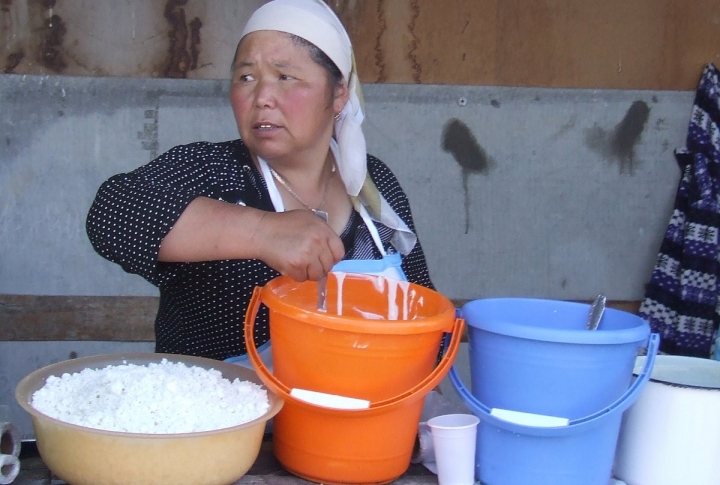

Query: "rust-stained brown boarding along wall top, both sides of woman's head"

xmin=0 ymin=0 xmax=720 ymax=90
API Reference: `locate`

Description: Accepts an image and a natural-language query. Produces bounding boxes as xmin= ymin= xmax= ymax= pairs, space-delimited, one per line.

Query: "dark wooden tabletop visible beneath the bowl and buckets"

xmin=12 ymin=436 xmax=438 ymax=485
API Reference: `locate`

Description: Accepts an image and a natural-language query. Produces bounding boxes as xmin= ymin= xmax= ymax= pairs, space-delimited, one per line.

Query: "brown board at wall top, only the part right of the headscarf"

xmin=338 ymin=0 xmax=720 ymax=90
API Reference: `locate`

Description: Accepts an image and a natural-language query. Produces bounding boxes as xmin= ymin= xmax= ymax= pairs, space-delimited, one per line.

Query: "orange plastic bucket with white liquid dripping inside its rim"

xmin=245 ymin=274 xmax=464 ymax=484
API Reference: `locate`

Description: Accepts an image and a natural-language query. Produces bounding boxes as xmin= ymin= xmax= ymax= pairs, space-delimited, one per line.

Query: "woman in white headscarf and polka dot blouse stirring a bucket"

xmin=87 ymin=0 xmax=433 ymax=360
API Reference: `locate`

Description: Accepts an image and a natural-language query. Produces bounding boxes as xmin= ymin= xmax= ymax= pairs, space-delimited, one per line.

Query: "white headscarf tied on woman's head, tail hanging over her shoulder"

xmin=241 ymin=0 xmax=417 ymax=254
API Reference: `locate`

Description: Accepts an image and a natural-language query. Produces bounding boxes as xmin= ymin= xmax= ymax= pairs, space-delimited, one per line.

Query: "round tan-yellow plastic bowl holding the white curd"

xmin=15 ymin=353 xmax=283 ymax=485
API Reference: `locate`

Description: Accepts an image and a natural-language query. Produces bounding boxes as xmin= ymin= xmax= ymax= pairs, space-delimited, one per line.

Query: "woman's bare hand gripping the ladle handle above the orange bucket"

xmin=253 ymin=210 xmax=345 ymax=281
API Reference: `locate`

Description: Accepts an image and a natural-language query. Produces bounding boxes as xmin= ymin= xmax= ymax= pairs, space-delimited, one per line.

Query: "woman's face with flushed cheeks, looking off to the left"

xmin=230 ymin=30 xmax=347 ymax=165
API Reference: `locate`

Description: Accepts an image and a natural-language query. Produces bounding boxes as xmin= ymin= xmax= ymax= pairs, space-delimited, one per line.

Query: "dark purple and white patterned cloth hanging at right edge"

xmin=639 ymin=64 xmax=720 ymax=358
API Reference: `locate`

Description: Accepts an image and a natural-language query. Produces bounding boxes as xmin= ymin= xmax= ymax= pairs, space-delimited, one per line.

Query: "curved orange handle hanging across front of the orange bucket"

xmin=244 ymin=286 xmax=465 ymax=413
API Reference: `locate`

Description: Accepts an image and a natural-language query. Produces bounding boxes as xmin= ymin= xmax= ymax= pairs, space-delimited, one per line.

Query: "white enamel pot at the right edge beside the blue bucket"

xmin=614 ymin=355 xmax=720 ymax=485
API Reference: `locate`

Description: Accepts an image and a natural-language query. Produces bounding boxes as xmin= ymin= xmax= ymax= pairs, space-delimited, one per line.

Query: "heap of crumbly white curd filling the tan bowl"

xmin=31 ymin=359 xmax=270 ymax=434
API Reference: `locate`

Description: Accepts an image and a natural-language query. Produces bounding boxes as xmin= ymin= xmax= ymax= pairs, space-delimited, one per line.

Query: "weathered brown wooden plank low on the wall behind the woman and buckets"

xmin=0 ymin=295 xmax=640 ymax=342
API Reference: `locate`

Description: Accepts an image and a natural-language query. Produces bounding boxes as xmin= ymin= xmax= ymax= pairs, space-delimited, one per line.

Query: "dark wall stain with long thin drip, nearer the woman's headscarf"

xmin=442 ymin=118 xmax=493 ymax=234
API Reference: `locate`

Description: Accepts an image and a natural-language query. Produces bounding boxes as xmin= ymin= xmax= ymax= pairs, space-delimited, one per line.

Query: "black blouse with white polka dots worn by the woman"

xmin=86 ymin=140 xmax=434 ymax=360
